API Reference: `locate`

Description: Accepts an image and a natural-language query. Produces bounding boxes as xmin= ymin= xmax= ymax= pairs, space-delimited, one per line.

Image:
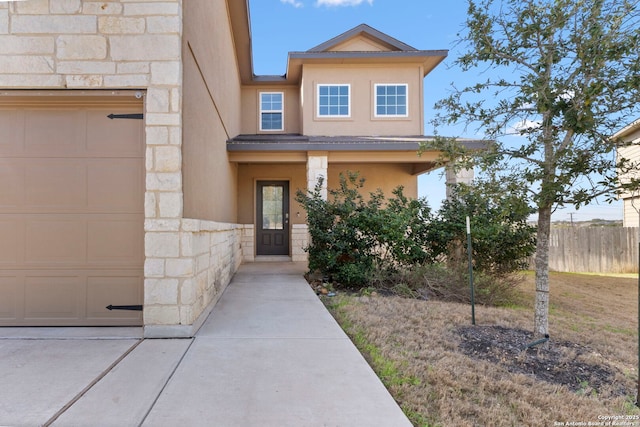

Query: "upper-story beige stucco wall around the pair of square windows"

xmin=302 ymin=64 xmax=424 ymax=136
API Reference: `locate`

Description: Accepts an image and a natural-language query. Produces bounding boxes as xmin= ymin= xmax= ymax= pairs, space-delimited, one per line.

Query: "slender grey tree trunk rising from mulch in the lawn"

xmin=534 ymin=207 xmax=551 ymax=339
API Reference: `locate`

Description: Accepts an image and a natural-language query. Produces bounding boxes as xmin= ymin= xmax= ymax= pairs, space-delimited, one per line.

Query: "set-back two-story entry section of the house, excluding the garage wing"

xmin=227 ymin=25 xmax=447 ymax=259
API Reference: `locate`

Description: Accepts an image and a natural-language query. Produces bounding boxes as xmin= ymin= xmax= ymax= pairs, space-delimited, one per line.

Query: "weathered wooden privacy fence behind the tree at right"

xmin=531 ymin=227 xmax=638 ymax=273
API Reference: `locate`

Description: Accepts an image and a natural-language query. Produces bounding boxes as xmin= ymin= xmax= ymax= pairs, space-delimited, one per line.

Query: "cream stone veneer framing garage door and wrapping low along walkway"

xmin=0 ymin=0 xmax=242 ymax=336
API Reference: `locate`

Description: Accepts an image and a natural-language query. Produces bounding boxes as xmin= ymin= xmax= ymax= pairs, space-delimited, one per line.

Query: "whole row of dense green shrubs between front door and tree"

xmin=296 ymin=172 xmax=535 ymax=304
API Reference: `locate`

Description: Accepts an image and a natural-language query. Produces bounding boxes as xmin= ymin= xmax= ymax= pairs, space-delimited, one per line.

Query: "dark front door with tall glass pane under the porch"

xmin=256 ymin=181 xmax=289 ymax=255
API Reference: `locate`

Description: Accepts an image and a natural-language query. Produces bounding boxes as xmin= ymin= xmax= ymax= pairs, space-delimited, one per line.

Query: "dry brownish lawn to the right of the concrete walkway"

xmin=324 ymin=273 xmax=640 ymax=426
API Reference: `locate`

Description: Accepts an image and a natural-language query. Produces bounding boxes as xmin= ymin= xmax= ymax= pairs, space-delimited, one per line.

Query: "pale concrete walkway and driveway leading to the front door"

xmin=0 ymin=263 xmax=411 ymax=427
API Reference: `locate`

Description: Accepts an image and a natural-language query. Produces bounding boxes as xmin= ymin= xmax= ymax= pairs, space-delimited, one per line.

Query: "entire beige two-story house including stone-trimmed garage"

xmin=0 ymin=0 xmax=460 ymax=337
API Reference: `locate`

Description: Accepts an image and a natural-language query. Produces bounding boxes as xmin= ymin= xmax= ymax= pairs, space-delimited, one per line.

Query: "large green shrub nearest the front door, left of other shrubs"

xmin=296 ymin=172 xmax=431 ymax=288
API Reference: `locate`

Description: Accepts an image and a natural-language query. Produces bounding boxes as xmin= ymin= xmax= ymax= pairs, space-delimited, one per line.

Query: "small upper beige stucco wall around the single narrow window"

xmin=241 ymin=85 xmax=302 ymax=135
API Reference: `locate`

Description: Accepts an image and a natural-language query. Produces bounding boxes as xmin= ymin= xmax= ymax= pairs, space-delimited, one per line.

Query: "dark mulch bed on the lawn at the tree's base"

xmin=457 ymin=326 xmax=626 ymax=396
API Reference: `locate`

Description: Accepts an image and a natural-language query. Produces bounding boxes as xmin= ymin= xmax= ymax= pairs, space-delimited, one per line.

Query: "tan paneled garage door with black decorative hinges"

xmin=0 ymin=92 xmax=144 ymax=326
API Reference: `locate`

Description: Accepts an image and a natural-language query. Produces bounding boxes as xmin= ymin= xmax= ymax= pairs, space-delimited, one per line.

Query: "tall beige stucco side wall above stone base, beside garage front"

xmin=182 ymin=0 xmax=241 ymax=223
